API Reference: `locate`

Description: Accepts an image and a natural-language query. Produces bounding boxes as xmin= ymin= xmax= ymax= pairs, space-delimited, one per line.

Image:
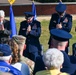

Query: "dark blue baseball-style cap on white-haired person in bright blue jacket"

xmin=0 ymin=44 xmax=12 ymax=56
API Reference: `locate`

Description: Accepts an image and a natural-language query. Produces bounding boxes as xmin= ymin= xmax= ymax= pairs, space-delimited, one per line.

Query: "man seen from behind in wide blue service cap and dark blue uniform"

xmin=51 ymin=29 xmax=76 ymax=74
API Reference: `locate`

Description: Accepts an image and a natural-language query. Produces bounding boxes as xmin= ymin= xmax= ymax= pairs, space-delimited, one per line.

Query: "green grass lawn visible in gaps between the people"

xmin=16 ymin=19 xmax=76 ymax=54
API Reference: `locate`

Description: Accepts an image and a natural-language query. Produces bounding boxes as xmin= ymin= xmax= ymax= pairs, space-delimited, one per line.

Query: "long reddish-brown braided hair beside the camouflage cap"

xmin=8 ymin=39 xmax=20 ymax=63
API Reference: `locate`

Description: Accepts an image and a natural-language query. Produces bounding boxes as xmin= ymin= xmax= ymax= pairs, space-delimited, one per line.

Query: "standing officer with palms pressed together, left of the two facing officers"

xmin=19 ymin=12 xmax=41 ymax=62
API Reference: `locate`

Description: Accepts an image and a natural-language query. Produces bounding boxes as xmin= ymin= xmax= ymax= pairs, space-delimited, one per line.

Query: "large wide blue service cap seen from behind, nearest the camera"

xmin=50 ymin=29 xmax=72 ymax=41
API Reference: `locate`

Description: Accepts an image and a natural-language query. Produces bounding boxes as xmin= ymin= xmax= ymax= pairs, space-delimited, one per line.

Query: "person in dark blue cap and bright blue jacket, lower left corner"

xmin=0 ymin=44 xmax=22 ymax=75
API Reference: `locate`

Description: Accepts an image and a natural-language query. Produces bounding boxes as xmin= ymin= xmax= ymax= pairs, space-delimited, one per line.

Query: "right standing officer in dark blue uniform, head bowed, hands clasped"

xmin=48 ymin=2 xmax=72 ymax=54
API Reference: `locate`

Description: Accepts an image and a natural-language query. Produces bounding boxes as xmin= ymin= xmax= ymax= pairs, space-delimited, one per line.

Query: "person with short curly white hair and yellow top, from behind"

xmin=36 ymin=48 xmax=69 ymax=75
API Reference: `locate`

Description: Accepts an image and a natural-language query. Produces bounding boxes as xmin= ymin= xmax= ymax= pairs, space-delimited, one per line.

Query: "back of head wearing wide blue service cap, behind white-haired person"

xmin=50 ymin=29 xmax=72 ymax=50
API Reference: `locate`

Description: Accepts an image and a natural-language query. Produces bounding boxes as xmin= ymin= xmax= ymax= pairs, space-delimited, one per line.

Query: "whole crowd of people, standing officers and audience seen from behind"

xmin=0 ymin=2 xmax=76 ymax=75
